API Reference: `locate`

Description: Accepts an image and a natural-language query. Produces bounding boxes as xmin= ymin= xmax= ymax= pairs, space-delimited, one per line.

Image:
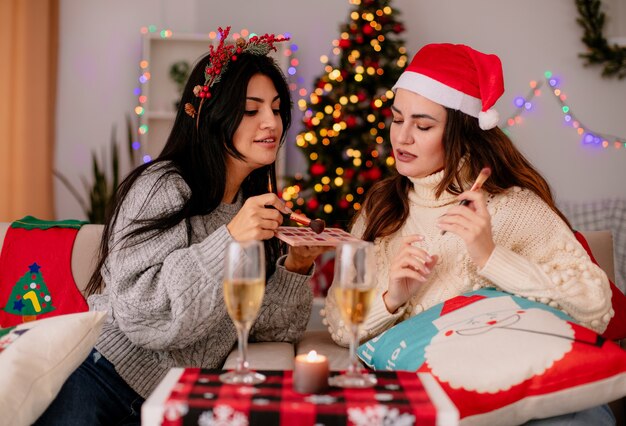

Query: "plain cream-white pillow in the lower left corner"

xmin=0 ymin=312 xmax=106 ymax=425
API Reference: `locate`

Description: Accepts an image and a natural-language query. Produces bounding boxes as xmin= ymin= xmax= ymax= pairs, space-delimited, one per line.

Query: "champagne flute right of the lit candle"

xmin=333 ymin=241 xmax=376 ymax=388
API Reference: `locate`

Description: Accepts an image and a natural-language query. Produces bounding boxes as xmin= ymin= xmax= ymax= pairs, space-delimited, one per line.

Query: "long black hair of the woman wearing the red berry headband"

xmin=86 ymin=53 xmax=292 ymax=295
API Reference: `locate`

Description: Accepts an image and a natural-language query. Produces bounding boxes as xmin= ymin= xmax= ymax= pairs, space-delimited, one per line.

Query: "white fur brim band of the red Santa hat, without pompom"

xmin=391 ymin=71 xmax=483 ymax=117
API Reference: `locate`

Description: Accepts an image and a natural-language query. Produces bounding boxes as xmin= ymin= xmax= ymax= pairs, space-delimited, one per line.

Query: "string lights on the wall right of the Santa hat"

xmin=502 ymin=71 xmax=626 ymax=149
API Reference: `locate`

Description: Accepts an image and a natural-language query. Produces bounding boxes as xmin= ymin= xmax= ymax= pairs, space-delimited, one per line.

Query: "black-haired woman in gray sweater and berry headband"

xmin=37 ymin=28 xmax=324 ymax=425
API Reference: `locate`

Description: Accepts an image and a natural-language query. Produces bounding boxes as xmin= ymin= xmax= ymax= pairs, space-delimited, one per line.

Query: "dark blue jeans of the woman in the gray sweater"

xmin=34 ymin=349 xmax=144 ymax=426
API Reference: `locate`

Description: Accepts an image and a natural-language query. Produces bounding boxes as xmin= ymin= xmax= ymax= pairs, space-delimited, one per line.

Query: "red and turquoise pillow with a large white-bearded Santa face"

xmin=358 ymin=289 xmax=626 ymax=425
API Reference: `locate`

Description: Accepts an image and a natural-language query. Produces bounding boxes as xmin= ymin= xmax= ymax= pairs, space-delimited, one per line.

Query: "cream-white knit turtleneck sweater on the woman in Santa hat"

xmin=322 ymin=171 xmax=614 ymax=346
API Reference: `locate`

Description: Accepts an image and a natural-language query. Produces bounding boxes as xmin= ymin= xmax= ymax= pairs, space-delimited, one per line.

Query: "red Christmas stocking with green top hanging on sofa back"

xmin=0 ymin=216 xmax=88 ymax=327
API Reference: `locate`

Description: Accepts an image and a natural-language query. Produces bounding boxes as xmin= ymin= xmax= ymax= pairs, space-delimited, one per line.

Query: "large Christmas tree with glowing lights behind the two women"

xmin=282 ymin=0 xmax=408 ymax=229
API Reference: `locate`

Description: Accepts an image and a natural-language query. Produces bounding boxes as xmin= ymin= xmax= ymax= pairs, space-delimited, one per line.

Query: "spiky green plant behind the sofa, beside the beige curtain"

xmin=53 ymin=115 xmax=137 ymax=224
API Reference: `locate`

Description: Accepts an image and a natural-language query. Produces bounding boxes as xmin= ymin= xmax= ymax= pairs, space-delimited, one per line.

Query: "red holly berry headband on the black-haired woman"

xmin=185 ymin=27 xmax=289 ymax=128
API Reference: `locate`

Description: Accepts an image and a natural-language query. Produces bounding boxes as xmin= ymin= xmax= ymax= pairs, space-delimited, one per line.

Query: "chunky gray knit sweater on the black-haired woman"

xmin=89 ymin=166 xmax=312 ymax=398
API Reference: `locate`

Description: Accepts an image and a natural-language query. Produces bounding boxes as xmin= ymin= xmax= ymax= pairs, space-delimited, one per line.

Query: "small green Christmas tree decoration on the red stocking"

xmin=4 ymin=263 xmax=55 ymax=322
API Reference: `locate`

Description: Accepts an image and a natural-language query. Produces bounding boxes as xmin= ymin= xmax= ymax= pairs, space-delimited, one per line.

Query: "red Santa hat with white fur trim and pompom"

xmin=392 ymin=43 xmax=504 ymax=130
